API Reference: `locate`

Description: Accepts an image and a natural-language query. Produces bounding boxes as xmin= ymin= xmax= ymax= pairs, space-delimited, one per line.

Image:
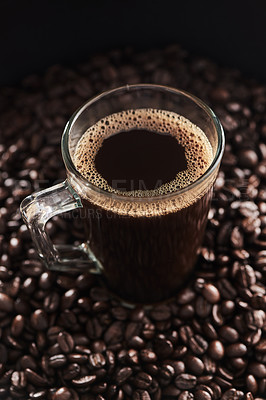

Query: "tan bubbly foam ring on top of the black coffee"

xmin=73 ymin=108 xmax=213 ymax=216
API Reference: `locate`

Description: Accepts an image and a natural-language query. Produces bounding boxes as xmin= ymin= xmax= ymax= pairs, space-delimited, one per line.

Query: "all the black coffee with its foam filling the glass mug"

xmin=74 ymin=109 xmax=212 ymax=303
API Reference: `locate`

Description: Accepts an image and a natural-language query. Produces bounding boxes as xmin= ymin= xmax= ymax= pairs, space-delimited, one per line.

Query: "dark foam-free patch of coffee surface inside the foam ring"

xmin=95 ymin=129 xmax=187 ymax=191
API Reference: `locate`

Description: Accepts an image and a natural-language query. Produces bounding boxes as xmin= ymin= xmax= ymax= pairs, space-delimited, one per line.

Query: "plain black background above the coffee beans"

xmin=0 ymin=0 xmax=266 ymax=85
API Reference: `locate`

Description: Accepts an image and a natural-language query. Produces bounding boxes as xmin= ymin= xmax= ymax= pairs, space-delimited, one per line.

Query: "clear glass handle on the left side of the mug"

xmin=20 ymin=180 xmax=101 ymax=274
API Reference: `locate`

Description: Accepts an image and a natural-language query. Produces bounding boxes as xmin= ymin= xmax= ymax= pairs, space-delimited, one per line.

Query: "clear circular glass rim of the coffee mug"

xmin=61 ymin=83 xmax=225 ymax=202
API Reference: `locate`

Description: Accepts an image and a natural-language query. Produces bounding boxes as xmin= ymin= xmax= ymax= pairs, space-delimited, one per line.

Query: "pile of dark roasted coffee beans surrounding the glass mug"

xmin=0 ymin=45 xmax=266 ymax=400
